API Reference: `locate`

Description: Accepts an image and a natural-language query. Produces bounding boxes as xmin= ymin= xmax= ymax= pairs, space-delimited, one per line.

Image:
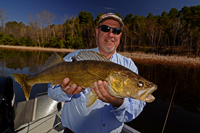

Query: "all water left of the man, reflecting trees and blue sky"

xmin=0 ymin=50 xmax=66 ymax=104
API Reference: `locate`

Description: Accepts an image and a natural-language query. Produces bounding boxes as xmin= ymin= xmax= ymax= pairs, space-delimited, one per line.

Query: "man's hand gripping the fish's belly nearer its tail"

xmin=60 ymin=78 xmax=83 ymax=95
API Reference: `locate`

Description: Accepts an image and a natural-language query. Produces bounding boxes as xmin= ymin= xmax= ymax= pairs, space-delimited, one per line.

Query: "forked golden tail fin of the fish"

xmin=11 ymin=74 xmax=32 ymax=101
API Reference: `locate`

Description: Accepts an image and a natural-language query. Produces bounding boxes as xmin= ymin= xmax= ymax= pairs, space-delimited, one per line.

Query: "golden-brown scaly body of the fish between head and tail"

xmin=27 ymin=61 xmax=121 ymax=87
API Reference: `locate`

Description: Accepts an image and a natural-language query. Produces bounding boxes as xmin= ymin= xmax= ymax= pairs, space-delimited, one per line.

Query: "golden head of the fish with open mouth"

xmin=108 ymin=72 xmax=157 ymax=102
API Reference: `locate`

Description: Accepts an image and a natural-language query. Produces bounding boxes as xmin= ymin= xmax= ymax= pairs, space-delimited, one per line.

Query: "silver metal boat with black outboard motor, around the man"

xmin=0 ymin=77 xmax=140 ymax=133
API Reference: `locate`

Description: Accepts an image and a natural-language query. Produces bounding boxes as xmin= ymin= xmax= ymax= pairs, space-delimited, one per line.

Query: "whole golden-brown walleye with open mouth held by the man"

xmin=12 ymin=51 xmax=157 ymax=107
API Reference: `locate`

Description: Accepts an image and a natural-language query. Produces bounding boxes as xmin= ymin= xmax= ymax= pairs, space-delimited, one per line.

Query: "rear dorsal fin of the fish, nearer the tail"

xmin=41 ymin=53 xmax=65 ymax=71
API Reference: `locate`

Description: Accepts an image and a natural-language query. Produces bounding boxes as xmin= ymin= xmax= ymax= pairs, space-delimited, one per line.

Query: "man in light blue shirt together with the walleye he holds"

xmin=12 ymin=13 xmax=157 ymax=133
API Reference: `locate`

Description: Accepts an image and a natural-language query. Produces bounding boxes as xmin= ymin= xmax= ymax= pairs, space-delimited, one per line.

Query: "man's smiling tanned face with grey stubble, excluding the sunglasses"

xmin=96 ymin=19 xmax=122 ymax=58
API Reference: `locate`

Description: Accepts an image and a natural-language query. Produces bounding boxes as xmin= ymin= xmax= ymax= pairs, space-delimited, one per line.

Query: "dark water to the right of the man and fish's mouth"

xmin=127 ymin=63 xmax=200 ymax=133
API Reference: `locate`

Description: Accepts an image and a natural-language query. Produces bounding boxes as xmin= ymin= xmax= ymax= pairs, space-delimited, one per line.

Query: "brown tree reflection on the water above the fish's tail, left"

xmin=0 ymin=50 xmax=50 ymax=75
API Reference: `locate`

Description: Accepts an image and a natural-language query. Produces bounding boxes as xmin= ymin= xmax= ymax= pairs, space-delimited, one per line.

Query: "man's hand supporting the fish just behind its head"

xmin=91 ymin=80 xmax=124 ymax=107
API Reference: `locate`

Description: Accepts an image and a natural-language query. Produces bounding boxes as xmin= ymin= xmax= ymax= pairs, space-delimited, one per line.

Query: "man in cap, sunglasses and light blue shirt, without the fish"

xmin=48 ymin=13 xmax=145 ymax=133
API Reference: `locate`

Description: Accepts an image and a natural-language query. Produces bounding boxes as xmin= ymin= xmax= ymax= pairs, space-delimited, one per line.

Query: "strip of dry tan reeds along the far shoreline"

xmin=0 ymin=45 xmax=200 ymax=69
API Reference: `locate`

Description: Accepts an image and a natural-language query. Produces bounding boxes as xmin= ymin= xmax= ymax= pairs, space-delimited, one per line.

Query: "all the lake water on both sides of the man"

xmin=0 ymin=49 xmax=200 ymax=133
